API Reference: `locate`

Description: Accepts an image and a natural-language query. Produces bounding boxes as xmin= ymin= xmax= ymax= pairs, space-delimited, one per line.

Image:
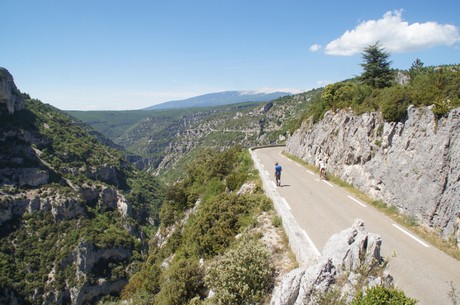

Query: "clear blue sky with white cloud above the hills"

xmin=0 ymin=0 xmax=460 ymax=110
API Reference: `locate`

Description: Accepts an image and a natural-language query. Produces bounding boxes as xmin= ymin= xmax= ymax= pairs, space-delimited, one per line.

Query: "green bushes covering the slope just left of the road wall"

xmin=122 ymin=147 xmax=274 ymax=304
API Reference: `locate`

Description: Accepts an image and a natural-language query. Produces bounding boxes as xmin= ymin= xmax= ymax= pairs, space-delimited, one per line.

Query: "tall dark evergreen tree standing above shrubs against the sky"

xmin=360 ymin=42 xmax=393 ymax=88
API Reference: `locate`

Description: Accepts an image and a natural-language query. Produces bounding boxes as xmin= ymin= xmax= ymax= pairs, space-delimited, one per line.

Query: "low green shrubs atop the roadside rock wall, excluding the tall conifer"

xmin=305 ymin=64 xmax=460 ymax=122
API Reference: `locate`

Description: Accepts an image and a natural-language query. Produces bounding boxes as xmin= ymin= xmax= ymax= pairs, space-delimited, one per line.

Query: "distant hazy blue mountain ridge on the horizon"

xmin=143 ymin=90 xmax=298 ymax=110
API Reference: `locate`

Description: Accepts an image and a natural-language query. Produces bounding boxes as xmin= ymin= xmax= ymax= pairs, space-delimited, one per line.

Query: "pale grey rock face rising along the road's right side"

xmin=286 ymin=106 xmax=460 ymax=243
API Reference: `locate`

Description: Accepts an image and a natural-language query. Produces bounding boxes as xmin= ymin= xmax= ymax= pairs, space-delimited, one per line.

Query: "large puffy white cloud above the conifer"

xmin=324 ymin=10 xmax=460 ymax=56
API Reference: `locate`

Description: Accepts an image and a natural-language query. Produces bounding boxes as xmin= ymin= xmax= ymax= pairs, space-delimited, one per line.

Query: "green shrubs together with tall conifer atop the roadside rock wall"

xmin=304 ymin=44 xmax=460 ymax=122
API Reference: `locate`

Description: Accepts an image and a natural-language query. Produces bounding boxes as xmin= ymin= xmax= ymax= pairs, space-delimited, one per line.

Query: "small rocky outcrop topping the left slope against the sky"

xmin=0 ymin=68 xmax=24 ymax=114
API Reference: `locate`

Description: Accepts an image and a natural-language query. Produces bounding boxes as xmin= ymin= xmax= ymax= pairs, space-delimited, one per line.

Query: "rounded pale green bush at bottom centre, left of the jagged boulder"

xmin=205 ymin=237 xmax=274 ymax=304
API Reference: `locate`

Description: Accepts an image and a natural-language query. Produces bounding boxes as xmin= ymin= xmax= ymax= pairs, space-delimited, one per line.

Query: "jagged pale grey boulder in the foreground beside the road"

xmin=270 ymin=219 xmax=393 ymax=305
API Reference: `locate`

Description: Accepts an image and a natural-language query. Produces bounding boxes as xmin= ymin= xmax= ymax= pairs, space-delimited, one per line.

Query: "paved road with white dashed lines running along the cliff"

xmin=254 ymin=147 xmax=460 ymax=305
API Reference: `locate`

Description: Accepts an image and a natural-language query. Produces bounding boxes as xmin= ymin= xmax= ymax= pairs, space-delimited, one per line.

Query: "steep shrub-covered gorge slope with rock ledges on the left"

xmin=0 ymin=73 xmax=161 ymax=304
